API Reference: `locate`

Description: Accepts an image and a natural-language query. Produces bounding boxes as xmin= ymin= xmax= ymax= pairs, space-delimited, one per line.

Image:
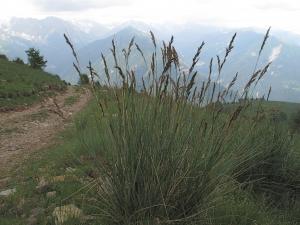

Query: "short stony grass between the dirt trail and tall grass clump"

xmin=0 ymin=98 xmax=101 ymax=225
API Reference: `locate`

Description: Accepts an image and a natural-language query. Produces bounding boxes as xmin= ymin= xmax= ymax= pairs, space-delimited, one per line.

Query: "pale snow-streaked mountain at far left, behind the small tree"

xmin=0 ymin=17 xmax=109 ymax=79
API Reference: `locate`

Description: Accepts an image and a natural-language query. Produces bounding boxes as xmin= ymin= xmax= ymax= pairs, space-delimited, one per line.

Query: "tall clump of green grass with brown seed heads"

xmin=65 ymin=30 xmax=296 ymax=225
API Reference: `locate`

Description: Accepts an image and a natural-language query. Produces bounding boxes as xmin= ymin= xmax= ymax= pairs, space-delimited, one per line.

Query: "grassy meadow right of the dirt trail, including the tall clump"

xmin=0 ymin=31 xmax=300 ymax=225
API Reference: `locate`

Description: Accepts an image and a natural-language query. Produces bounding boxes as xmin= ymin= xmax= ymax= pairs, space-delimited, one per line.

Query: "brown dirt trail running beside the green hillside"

xmin=0 ymin=87 xmax=91 ymax=186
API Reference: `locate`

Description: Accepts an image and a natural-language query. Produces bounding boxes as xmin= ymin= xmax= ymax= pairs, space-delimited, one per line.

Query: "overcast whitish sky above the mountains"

xmin=0 ymin=0 xmax=300 ymax=34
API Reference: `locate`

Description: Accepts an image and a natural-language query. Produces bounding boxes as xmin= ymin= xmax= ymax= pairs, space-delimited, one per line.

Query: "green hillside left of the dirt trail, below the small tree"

xmin=0 ymin=59 xmax=66 ymax=111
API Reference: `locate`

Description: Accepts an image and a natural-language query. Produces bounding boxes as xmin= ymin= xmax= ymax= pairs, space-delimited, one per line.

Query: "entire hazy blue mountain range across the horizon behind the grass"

xmin=0 ymin=17 xmax=300 ymax=102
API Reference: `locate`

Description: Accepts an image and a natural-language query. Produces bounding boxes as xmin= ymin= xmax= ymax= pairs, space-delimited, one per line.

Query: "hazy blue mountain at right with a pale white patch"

xmin=164 ymin=30 xmax=300 ymax=102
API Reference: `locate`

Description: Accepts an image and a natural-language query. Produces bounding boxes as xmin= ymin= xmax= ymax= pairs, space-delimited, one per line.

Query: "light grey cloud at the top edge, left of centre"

xmin=33 ymin=0 xmax=131 ymax=12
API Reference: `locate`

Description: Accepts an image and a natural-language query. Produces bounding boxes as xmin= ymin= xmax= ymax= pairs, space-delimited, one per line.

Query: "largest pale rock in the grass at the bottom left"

xmin=52 ymin=204 xmax=82 ymax=225
